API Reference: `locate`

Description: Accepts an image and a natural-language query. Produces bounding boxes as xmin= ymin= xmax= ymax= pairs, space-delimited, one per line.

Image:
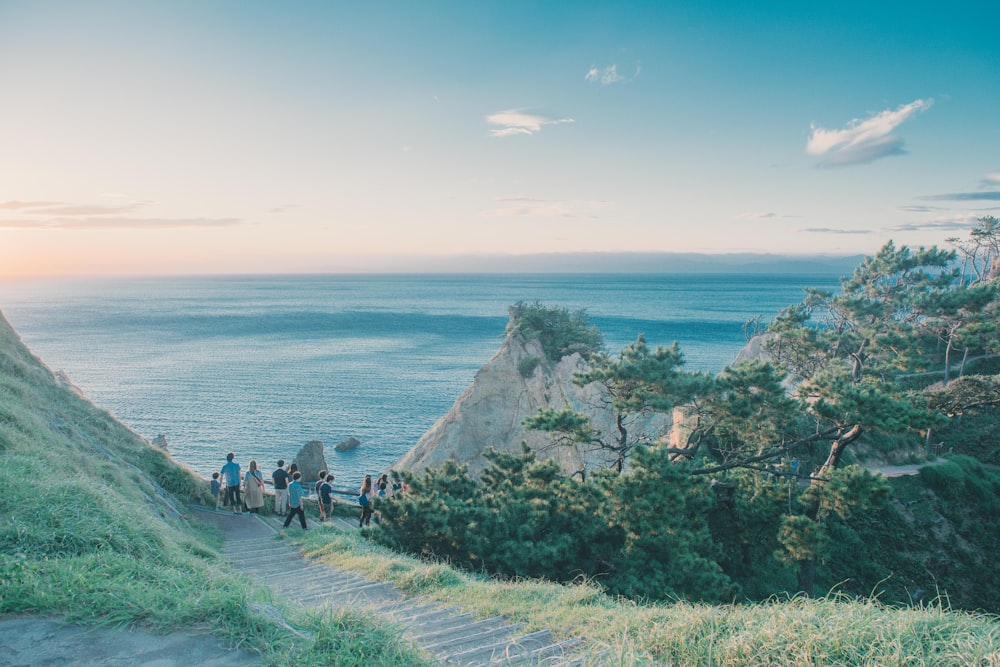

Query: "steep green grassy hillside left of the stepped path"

xmin=0 ymin=316 xmax=423 ymax=665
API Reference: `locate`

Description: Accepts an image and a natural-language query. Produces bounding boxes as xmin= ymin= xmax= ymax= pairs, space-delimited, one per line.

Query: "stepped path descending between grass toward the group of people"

xmin=193 ymin=507 xmax=580 ymax=667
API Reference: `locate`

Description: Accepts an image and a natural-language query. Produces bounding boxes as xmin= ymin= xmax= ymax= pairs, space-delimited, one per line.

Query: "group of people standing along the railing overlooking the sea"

xmin=211 ymin=452 xmax=404 ymax=530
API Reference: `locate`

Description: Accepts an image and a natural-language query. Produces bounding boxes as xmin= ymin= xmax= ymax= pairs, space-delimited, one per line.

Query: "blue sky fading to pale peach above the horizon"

xmin=0 ymin=0 xmax=1000 ymax=278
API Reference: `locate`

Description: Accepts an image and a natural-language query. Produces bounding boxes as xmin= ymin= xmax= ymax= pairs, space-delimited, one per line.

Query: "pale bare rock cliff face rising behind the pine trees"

xmin=395 ymin=334 xmax=670 ymax=475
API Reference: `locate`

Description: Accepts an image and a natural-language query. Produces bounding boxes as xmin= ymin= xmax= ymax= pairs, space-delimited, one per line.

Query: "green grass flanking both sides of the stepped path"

xmin=0 ymin=310 xmax=1000 ymax=667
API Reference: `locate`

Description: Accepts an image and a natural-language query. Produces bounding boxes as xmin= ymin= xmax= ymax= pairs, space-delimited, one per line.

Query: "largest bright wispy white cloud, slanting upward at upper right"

xmin=806 ymin=99 xmax=934 ymax=167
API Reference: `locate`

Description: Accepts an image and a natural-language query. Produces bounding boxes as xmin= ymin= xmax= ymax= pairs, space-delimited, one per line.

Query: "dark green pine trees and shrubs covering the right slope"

xmin=374 ymin=218 xmax=1000 ymax=612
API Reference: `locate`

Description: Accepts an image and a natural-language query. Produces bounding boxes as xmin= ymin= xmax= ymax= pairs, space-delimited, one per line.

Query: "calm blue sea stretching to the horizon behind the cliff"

xmin=0 ymin=274 xmax=837 ymax=485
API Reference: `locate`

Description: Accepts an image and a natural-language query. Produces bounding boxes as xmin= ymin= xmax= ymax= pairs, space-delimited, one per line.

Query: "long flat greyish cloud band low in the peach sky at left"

xmin=0 ymin=200 xmax=243 ymax=230
